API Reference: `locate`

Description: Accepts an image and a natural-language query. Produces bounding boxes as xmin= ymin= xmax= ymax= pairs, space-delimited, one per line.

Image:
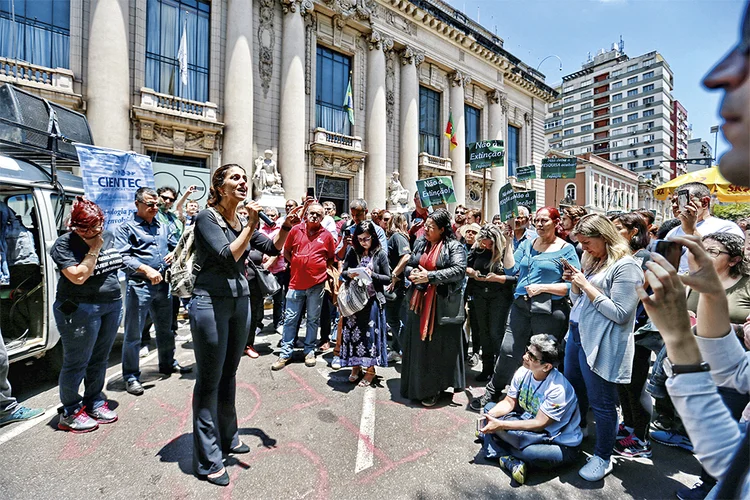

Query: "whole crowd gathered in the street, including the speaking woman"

xmin=0 ymin=2 xmax=750 ymax=500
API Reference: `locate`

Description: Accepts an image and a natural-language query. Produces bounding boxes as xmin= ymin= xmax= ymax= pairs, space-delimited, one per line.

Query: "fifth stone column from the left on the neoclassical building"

xmin=399 ymin=47 xmax=424 ymax=203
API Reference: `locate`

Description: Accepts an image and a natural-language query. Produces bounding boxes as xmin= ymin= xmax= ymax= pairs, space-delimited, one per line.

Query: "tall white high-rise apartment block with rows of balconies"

xmin=544 ymin=42 xmax=674 ymax=184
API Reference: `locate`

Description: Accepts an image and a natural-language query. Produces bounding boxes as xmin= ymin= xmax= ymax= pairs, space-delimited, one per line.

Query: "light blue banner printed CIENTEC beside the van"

xmin=75 ymin=144 xmax=154 ymax=231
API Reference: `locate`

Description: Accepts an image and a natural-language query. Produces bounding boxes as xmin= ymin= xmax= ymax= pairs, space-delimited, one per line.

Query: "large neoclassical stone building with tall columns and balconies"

xmin=0 ymin=0 xmax=556 ymax=213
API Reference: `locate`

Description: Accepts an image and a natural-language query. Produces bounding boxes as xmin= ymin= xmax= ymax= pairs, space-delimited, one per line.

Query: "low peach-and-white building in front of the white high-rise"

xmin=544 ymin=151 xmax=639 ymax=214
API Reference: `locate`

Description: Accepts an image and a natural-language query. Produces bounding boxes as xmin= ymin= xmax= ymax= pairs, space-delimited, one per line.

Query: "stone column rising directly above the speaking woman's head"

xmin=222 ymin=0 xmax=254 ymax=168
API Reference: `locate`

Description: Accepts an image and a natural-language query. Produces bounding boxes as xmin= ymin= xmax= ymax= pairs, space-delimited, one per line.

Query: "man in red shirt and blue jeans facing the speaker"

xmin=271 ymin=203 xmax=336 ymax=370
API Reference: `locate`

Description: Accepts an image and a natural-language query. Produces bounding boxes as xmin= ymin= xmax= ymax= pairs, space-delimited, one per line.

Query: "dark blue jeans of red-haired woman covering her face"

xmin=53 ymin=299 xmax=122 ymax=415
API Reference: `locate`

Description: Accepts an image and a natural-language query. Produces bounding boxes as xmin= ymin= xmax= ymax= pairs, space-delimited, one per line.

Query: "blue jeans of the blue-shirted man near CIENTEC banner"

xmin=122 ymin=280 xmax=174 ymax=382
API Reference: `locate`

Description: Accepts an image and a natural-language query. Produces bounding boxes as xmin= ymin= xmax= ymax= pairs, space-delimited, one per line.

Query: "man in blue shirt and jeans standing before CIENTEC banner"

xmin=115 ymin=187 xmax=192 ymax=396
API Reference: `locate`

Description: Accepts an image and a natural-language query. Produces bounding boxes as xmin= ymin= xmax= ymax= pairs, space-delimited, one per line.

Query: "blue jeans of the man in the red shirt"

xmin=281 ymin=283 xmax=325 ymax=359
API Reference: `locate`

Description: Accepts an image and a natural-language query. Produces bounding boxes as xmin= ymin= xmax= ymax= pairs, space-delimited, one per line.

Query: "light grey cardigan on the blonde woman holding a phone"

xmin=570 ymin=256 xmax=643 ymax=384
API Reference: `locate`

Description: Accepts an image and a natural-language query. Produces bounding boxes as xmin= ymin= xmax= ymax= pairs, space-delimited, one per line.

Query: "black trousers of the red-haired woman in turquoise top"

xmin=486 ymin=297 xmax=570 ymax=401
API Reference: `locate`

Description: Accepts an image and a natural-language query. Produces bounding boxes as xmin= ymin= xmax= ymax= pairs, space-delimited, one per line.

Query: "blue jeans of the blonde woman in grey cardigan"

xmin=565 ymin=322 xmax=618 ymax=460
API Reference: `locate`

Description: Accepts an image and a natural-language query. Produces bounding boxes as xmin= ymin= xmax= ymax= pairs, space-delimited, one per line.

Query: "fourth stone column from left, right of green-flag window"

xmin=365 ymin=31 xmax=393 ymax=209
